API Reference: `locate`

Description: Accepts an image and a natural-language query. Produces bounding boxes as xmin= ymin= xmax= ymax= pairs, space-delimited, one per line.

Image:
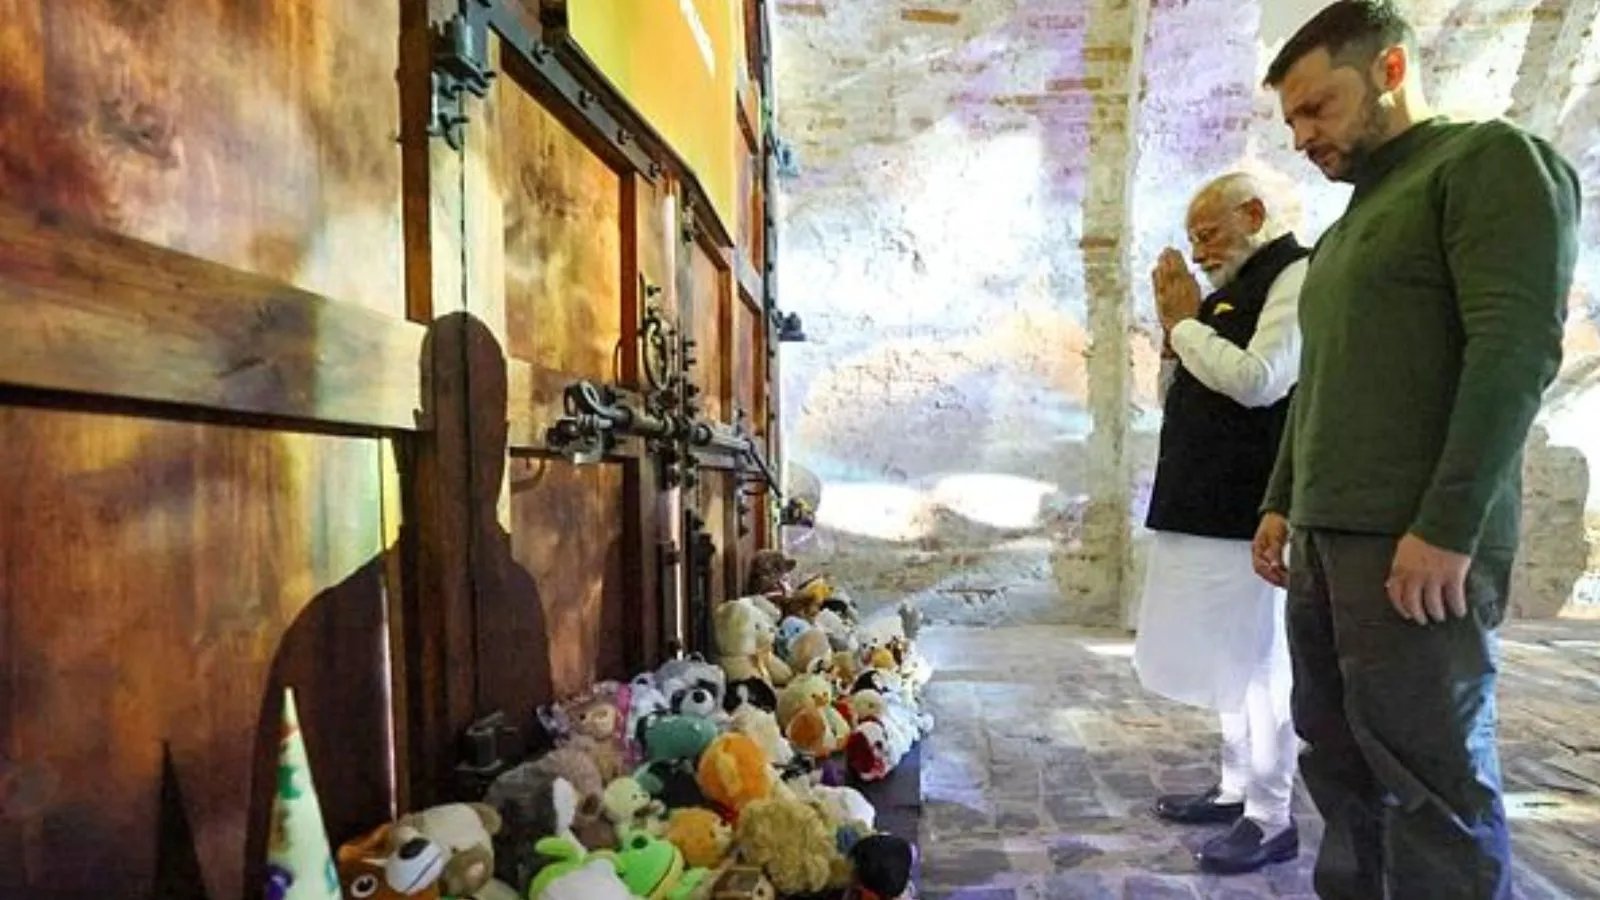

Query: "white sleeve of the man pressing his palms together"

xmin=1171 ymin=259 xmax=1309 ymax=407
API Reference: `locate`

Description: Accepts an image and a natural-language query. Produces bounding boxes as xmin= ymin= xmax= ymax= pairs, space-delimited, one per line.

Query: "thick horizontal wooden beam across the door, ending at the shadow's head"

xmin=0 ymin=203 xmax=426 ymax=431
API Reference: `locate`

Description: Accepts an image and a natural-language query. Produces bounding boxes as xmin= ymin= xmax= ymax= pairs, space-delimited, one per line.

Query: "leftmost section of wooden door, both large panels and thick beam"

xmin=0 ymin=0 xmax=427 ymax=897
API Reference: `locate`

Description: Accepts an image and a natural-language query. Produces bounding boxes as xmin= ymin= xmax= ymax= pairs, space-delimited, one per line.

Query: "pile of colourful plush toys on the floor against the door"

xmin=269 ymin=551 xmax=931 ymax=900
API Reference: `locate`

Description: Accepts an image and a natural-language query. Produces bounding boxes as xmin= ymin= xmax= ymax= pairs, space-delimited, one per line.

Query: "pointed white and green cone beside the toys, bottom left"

xmin=266 ymin=687 xmax=339 ymax=900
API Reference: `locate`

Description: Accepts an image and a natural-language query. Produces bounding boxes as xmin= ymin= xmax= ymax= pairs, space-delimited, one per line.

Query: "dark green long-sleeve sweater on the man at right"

xmin=1262 ymin=119 xmax=1581 ymax=554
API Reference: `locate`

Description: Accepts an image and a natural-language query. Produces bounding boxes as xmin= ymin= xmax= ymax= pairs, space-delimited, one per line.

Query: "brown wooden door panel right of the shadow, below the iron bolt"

xmin=492 ymin=458 xmax=635 ymax=716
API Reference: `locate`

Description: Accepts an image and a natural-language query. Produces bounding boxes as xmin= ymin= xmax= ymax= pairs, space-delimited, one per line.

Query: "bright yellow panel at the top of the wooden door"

xmin=566 ymin=0 xmax=744 ymax=232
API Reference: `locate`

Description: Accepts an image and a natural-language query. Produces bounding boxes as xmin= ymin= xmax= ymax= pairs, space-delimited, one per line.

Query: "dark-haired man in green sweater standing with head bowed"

xmin=1254 ymin=0 xmax=1579 ymax=900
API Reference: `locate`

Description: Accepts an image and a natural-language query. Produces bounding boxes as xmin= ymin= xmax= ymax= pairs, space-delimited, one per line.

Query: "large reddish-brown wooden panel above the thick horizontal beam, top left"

xmin=0 ymin=0 xmax=405 ymax=315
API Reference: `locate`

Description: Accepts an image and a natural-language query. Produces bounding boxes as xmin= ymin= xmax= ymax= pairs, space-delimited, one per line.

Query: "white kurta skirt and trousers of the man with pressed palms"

xmin=1133 ymin=532 xmax=1298 ymax=825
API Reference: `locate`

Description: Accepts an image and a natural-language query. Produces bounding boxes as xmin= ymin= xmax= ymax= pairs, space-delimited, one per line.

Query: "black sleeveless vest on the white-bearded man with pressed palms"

xmin=1144 ymin=235 xmax=1307 ymax=540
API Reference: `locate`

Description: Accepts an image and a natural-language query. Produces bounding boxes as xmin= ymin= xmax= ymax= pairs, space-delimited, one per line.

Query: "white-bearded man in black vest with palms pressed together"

xmin=1134 ymin=173 xmax=1307 ymax=873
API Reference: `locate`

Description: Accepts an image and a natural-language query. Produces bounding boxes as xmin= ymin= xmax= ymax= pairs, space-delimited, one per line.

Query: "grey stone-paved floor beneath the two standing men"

xmin=920 ymin=621 xmax=1600 ymax=900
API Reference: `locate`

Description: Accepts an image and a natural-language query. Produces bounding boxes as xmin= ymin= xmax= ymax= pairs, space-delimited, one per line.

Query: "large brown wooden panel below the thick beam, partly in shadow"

xmin=0 ymin=407 xmax=394 ymax=898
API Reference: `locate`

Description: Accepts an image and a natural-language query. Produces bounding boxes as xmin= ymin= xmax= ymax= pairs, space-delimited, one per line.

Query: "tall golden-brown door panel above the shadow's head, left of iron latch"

xmin=494 ymin=71 xmax=622 ymax=381
